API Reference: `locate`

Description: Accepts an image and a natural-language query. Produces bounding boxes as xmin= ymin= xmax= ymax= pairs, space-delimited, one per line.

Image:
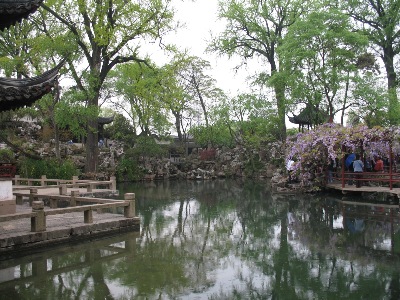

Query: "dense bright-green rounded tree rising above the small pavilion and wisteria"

xmin=278 ymin=6 xmax=368 ymax=125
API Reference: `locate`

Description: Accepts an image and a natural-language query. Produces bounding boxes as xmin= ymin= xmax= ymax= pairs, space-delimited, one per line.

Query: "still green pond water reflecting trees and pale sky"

xmin=0 ymin=180 xmax=400 ymax=300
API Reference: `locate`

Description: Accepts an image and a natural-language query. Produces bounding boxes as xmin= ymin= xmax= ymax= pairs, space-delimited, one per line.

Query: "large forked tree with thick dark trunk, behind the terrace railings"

xmin=42 ymin=0 xmax=173 ymax=172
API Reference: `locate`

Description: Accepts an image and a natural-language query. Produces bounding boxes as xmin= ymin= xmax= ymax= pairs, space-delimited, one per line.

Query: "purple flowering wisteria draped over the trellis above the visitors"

xmin=286 ymin=123 xmax=400 ymax=184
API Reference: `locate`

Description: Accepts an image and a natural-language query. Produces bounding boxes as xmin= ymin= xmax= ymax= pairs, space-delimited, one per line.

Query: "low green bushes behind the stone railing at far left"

xmin=18 ymin=158 xmax=80 ymax=179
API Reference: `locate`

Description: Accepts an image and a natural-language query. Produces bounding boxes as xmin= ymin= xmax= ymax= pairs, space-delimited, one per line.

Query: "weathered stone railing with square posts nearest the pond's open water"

xmin=0 ymin=188 xmax=135 ymax=232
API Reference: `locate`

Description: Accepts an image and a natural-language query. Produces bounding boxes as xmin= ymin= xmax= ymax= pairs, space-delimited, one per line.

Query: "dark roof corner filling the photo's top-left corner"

xmin=0 ymin=0 xmax=43 ymax=31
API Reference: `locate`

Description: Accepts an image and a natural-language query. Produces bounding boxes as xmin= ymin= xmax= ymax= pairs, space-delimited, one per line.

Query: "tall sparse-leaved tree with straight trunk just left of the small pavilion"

xmin=210 ymin=0 xmax=307 ymax=139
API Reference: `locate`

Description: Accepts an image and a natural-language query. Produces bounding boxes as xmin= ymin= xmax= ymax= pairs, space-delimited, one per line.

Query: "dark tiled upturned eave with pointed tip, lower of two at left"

xmin=0 ymin=61 xmax=64 ymax=111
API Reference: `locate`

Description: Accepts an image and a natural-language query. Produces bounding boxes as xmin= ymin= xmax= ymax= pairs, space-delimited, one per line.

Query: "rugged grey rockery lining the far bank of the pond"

xmin=2 ymin=119 xmax=298 ymax=192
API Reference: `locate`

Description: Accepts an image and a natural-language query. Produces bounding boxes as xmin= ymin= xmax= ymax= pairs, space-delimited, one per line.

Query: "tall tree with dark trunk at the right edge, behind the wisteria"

xmin=341 ymin=0 xmax=400 ymax=125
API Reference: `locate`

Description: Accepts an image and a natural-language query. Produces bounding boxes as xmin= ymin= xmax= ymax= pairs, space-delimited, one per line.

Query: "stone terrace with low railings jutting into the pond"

xmin=0 ymin=181 xmax=140 ymax=261
